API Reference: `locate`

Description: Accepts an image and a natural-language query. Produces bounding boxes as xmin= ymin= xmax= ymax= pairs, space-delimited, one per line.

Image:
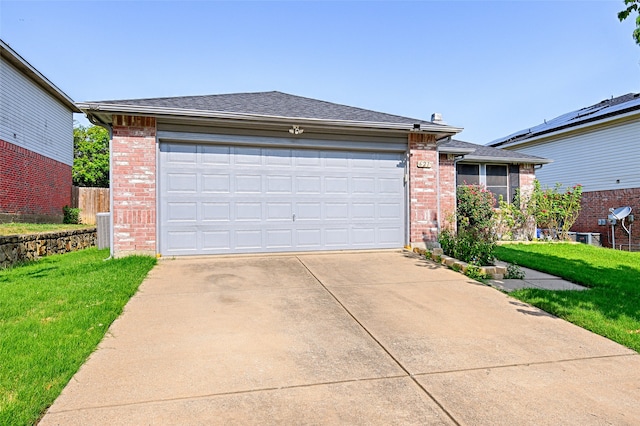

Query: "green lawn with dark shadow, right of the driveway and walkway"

xmin=496 ymin=243 xmax=640 ymax=352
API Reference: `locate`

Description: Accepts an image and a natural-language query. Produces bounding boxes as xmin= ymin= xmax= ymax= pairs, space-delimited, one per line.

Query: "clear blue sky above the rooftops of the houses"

xmin=0 ymin=0 xmax=640 ymax=144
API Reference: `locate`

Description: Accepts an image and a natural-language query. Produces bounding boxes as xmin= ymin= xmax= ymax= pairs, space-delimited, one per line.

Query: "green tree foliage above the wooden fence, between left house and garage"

xmin=72 ymin=125 xmax=109 ymax=188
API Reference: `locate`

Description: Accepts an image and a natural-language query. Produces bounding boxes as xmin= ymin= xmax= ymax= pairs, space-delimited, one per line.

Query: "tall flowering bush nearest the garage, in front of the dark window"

xmin=438 ymin=185 xmax=496 ymax=265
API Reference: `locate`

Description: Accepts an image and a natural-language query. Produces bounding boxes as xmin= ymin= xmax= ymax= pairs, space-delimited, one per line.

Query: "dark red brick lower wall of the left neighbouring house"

xmin=0 ymin=139 xmax=72 ymax=222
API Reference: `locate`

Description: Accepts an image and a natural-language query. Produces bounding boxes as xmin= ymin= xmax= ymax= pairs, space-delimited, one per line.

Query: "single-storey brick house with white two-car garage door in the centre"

xmin=78 ymin=92 xmax=545 ymax=256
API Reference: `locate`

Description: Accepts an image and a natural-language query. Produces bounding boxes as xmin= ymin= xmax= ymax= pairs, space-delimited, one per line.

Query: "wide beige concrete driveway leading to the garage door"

xmin=41 ymin=251 xmax=640 ymax=425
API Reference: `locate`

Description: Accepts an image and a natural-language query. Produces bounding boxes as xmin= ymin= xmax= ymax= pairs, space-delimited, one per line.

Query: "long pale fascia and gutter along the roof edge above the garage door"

xmin=76 ymin=102 xmax=463 ymax=135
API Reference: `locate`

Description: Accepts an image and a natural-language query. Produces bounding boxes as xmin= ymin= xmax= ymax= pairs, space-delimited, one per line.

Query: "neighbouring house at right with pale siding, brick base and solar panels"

xmin=488 ymin=93 xmax=640 ymax=250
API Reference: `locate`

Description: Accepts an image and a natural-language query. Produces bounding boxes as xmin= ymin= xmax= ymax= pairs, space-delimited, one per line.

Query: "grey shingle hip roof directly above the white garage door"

xmin=95 ymin=91 xmax=433 ymax=125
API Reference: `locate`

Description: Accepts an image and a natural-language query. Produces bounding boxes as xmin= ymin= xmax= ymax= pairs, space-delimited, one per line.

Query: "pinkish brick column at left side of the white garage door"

xmin=111 ymin=115 xmax=156 ymax=257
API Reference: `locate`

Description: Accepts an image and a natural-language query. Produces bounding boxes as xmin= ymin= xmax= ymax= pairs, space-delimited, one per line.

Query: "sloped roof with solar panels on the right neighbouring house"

xmin=487 ymin=93 xmax=640 ymax=146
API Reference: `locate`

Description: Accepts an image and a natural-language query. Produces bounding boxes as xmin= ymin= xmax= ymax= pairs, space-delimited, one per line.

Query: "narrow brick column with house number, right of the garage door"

xmin=409 ymin=132 xmax=438 ymax=247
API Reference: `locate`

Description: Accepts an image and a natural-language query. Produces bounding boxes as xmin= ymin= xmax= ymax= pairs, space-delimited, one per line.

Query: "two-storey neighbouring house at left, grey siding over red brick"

xmin=0 ymin=40 xmax=80 ymax=222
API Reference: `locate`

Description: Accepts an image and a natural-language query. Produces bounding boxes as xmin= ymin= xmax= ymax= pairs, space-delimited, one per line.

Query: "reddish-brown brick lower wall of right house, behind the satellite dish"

xmin=571 ymin=188 xmax=640 ymax=251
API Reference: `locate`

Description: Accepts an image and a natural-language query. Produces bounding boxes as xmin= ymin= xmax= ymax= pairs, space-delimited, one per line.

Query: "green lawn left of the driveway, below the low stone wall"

xmin=0 ymin=248 xmax=156 ymax=425
